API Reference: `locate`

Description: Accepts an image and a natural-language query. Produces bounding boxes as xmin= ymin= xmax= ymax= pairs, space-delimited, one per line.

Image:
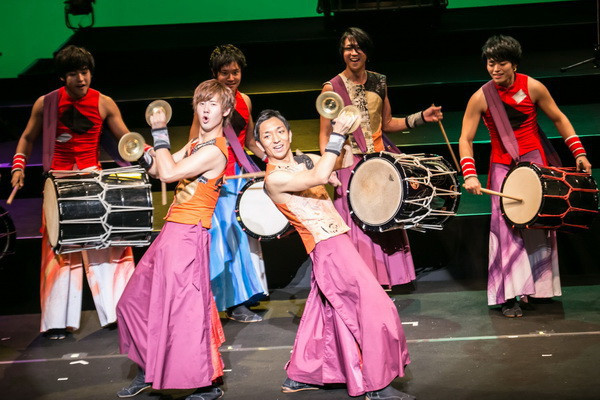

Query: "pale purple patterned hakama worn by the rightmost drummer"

xmin=488 ymin=150 xmax=561 ymax=305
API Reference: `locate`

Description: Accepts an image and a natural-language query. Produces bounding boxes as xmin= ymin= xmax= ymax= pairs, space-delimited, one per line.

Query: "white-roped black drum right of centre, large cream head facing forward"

xmin=348 ymin=152 xmax=460 ymax=232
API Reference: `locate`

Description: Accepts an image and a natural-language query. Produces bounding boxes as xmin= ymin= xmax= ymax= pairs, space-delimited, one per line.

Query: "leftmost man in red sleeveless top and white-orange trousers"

xmin=12 ymin=46 xmax=134 ymax=339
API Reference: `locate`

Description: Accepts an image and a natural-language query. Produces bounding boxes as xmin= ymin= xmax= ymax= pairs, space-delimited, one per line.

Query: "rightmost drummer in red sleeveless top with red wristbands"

xmin=459 ymin=35 xmax=592 ymax=317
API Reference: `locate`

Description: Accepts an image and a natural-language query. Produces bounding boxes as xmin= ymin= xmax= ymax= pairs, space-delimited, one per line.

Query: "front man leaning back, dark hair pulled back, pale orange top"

xmin=254 ymin=110 xmax=414 ymax=400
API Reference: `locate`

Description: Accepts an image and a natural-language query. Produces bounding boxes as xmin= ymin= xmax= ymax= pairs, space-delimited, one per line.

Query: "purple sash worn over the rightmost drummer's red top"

xmin=482 ymin=81 xmax=562 ymax=167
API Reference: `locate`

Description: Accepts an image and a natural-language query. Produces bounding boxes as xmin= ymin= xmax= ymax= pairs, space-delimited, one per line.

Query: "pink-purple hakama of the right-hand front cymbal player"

xmin=286 ymin=234 xmax=410 ymax=396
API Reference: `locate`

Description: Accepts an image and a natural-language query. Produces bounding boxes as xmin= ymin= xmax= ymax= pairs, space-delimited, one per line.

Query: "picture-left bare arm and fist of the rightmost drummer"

xmin=458 ymin=89 xmax=487 ymax=194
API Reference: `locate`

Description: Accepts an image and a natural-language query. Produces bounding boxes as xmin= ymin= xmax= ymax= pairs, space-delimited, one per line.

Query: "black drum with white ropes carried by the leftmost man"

xmin=43 ymin=167 xmax=153 ymax=254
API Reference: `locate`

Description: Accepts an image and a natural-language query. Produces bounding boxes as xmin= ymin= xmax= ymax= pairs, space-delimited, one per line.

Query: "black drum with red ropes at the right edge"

xmin=500 ymin=162 xmax=598 ymax=231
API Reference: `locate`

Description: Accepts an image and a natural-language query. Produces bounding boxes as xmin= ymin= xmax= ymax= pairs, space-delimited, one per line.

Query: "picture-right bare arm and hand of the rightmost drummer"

xmin=527 ymin=78 xmax=592 ymax=173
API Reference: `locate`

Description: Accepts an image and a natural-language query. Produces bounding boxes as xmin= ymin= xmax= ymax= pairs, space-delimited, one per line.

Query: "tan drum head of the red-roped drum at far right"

xmin=500 ymin=165 xmax=543 ymax=225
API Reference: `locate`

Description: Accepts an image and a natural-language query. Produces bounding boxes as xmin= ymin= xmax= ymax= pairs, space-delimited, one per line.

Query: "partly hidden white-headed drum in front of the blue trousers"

xmin=235 ymin=178 xmax=293 ymax=240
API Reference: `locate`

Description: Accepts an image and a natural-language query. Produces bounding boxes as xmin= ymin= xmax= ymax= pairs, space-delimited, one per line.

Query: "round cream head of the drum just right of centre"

xmin=348 ymin=157 xmax=404 ymax=226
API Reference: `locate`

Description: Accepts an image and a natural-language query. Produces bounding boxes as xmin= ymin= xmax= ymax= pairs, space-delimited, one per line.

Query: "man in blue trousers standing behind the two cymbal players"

xmin=190 ymin=44 xmax=268 ymax=322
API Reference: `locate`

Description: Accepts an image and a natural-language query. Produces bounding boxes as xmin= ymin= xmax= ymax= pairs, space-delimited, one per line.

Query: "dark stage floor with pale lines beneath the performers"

xmin=0 ymin=278 xmax=600 ymax=400
